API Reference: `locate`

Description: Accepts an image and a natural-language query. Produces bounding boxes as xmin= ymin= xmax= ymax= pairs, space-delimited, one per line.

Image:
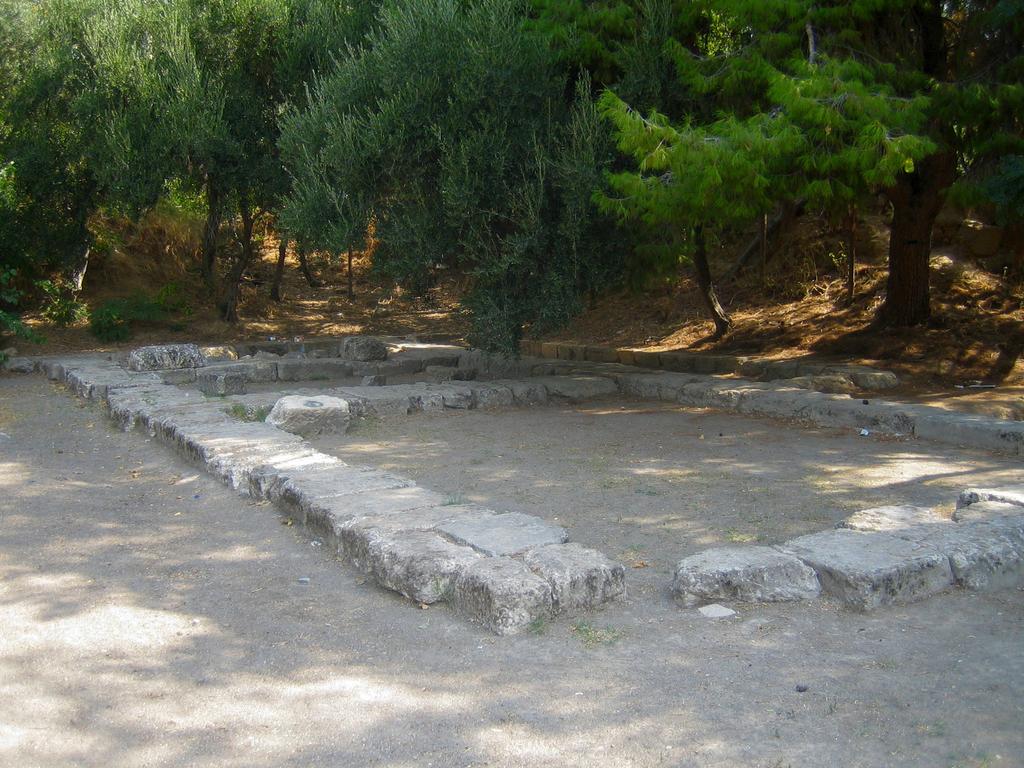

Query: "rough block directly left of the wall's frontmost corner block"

xmin=366 ymin=530 xmax=481 ymax=603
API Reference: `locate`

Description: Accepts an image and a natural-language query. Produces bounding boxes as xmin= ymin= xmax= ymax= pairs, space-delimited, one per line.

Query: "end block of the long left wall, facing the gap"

xmin=523 ymin=544 xmax=626 ymax=613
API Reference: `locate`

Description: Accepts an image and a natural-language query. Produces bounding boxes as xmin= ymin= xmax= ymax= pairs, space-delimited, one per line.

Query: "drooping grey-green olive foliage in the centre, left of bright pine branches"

xmin=281 ymin=0 xmax=622 ymax=350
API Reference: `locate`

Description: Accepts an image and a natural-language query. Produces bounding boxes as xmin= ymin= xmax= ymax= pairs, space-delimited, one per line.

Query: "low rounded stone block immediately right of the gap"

xmin=672 ymin=547 xmax=821 ymax=607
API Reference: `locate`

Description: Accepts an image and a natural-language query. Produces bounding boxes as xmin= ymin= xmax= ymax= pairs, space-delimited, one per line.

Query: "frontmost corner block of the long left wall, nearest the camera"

xmin=452 ymin=557 xmax=552 ymax=635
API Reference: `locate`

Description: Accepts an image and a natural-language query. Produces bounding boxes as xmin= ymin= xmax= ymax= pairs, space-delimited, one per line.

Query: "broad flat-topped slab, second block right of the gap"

xmin=778 ymin=528 xmax=953 ymax=610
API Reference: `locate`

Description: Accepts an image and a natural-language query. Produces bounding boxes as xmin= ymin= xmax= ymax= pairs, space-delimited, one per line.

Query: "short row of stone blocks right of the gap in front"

xmin=672 ymin=486 xmax=1024 ymax=610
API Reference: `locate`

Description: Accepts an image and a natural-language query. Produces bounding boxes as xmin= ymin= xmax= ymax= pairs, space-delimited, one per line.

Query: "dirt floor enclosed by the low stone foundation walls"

xmin=312 ymin=399 xmax=1021 ymax=605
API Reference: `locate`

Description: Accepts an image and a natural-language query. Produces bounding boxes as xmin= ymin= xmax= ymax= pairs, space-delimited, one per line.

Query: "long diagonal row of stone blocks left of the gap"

xmin=37 ymin=354 xmax=625 ymax=634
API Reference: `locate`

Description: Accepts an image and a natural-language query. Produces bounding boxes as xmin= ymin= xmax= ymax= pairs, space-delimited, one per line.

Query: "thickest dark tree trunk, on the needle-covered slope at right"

xmin=879 ymin=153 xmax=954 ymax=326
